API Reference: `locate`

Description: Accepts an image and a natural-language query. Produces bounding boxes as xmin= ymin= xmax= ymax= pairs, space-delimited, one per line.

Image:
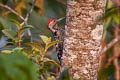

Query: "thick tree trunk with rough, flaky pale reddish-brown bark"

xmin=63 ymin=0 xmax=106 ymax=80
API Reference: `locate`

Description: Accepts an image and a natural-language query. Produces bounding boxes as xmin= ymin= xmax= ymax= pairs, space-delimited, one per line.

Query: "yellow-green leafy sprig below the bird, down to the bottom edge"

xmin=26 ymin=35 xmax=61 ymax=80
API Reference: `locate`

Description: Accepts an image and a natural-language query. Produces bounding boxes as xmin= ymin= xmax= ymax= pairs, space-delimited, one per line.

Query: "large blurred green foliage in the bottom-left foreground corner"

xmin=0 ymin=48 xmax=37 ymax=80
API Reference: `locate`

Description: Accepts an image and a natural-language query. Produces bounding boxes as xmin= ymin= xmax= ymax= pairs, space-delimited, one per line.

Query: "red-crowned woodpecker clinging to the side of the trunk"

xmin=47 ymin=19 xmax=63 ymax=64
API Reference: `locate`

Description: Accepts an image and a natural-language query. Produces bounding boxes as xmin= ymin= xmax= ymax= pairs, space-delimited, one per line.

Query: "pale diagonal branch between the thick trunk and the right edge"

xmin=101 ymin=36 xmax=120 ymax=53
